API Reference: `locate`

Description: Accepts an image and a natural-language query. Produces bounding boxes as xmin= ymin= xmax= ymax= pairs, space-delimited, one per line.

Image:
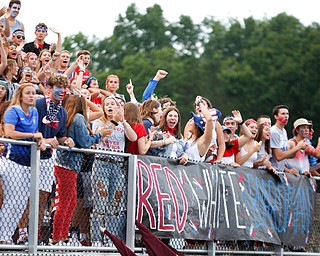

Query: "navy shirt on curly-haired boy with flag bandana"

xmin=36 ymin=98 xmax=67 ymax=159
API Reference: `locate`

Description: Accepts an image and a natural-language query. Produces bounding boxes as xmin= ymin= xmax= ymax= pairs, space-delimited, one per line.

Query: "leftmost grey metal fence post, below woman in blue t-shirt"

xmin=28 ymin=143 xmax=40 ymax=254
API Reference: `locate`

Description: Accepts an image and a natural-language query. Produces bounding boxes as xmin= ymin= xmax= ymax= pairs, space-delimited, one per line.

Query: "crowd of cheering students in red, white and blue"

xmin=0 ymin=0 xmax=320 ymax=249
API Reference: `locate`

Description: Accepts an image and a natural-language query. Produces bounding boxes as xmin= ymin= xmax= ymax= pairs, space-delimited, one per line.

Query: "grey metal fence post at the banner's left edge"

xmin=126 ymin=155 xmax=137 ymax=250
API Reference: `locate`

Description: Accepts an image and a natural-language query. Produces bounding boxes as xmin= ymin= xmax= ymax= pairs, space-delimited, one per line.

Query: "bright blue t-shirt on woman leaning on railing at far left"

xmin=4 ymin=106 xmax=39 ymax=166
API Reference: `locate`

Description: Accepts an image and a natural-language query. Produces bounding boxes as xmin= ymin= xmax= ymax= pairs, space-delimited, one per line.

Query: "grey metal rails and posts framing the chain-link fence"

xmin=0 ymin=138 xmax=320 ymax=256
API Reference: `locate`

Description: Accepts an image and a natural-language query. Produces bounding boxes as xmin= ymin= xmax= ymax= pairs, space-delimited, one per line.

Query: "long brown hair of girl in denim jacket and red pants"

xmin=63 ymin=95 xmax=89 ymax=129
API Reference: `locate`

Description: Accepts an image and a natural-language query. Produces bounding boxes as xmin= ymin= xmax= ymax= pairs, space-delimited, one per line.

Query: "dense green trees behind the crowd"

xmin=63 ymin=4 xmax=320 ymax=136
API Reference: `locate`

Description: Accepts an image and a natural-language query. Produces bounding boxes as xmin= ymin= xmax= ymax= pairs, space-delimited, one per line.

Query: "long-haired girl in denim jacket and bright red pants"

xmin=52 ymin=95 xmax=109 ymax=244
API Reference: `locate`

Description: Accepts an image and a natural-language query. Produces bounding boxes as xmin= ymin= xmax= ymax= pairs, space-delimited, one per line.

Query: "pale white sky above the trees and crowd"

xmin=16 ymin=0 xmax=320 ymax=43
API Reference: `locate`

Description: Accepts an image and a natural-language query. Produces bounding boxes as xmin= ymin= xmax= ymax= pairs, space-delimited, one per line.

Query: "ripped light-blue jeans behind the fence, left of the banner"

xmin=91 ymin=157 xmax=128 ymax=242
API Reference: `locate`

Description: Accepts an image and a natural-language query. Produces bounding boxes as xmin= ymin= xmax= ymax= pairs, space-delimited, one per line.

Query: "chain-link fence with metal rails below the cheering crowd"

xmin=0 ymin=139 xmax=320 ymax=255
